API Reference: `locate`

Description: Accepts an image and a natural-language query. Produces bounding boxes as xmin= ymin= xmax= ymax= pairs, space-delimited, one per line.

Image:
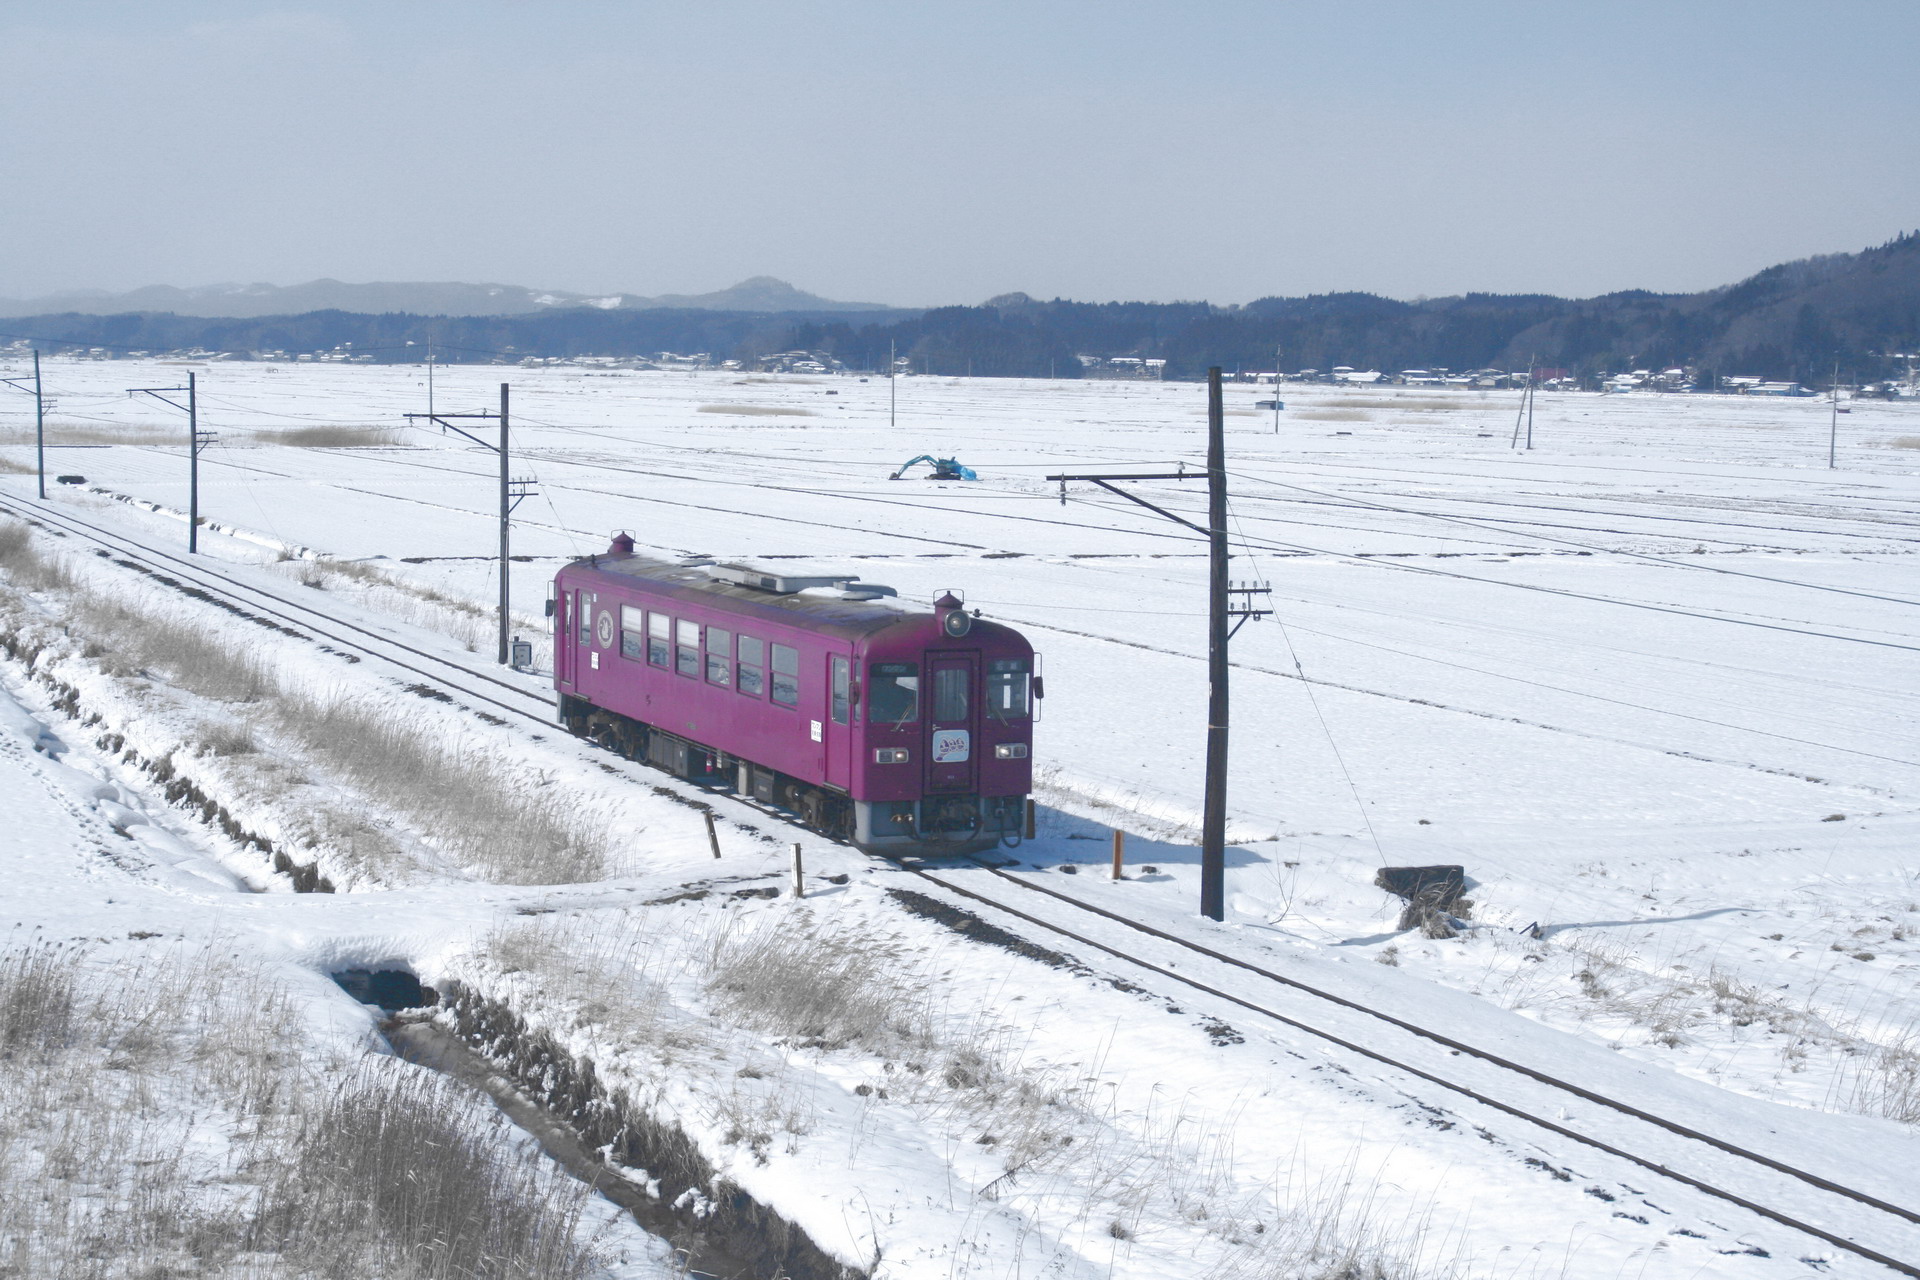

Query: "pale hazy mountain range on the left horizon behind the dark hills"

xmin=0 ymin=276 xmax=889 ymax=320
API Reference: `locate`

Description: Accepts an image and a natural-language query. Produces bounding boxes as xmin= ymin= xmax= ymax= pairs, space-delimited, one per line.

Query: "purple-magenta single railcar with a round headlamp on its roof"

xmin=553 ymin=535 xmax=1041 ymax=854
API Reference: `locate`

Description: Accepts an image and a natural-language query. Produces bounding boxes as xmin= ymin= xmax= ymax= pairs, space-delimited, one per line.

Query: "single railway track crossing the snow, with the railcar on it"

xmin=0 ymin=487 xmax=1920 ymax=1280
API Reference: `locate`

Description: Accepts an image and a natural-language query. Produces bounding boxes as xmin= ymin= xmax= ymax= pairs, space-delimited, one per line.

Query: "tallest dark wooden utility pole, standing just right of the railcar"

xmin=1048 ymin=365 xmax=1273 ymax=919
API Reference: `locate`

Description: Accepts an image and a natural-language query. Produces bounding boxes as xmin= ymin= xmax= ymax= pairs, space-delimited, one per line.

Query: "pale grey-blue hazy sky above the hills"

xmin=0 ymin=0 xmax=1920 ymax=305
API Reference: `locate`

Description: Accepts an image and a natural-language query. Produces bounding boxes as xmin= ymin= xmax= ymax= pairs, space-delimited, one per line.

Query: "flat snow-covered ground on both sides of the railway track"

xmin=0 ymin=359 xmax=1920 ymax=1278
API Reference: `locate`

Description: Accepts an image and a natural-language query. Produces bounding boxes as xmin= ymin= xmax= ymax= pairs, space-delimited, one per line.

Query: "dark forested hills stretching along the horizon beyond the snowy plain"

xmin=15 ymin=234 xmax=1920 ymax=384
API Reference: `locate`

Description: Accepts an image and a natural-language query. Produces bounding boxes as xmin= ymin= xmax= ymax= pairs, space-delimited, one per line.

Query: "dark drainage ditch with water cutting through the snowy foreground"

xmin=334 ymin=969 xmax=866 ymax=1280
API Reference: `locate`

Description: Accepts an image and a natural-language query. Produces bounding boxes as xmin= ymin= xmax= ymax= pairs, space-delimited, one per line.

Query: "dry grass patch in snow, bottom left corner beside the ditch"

xmin=0 ymin=948 xmax=605 ymax=1280
